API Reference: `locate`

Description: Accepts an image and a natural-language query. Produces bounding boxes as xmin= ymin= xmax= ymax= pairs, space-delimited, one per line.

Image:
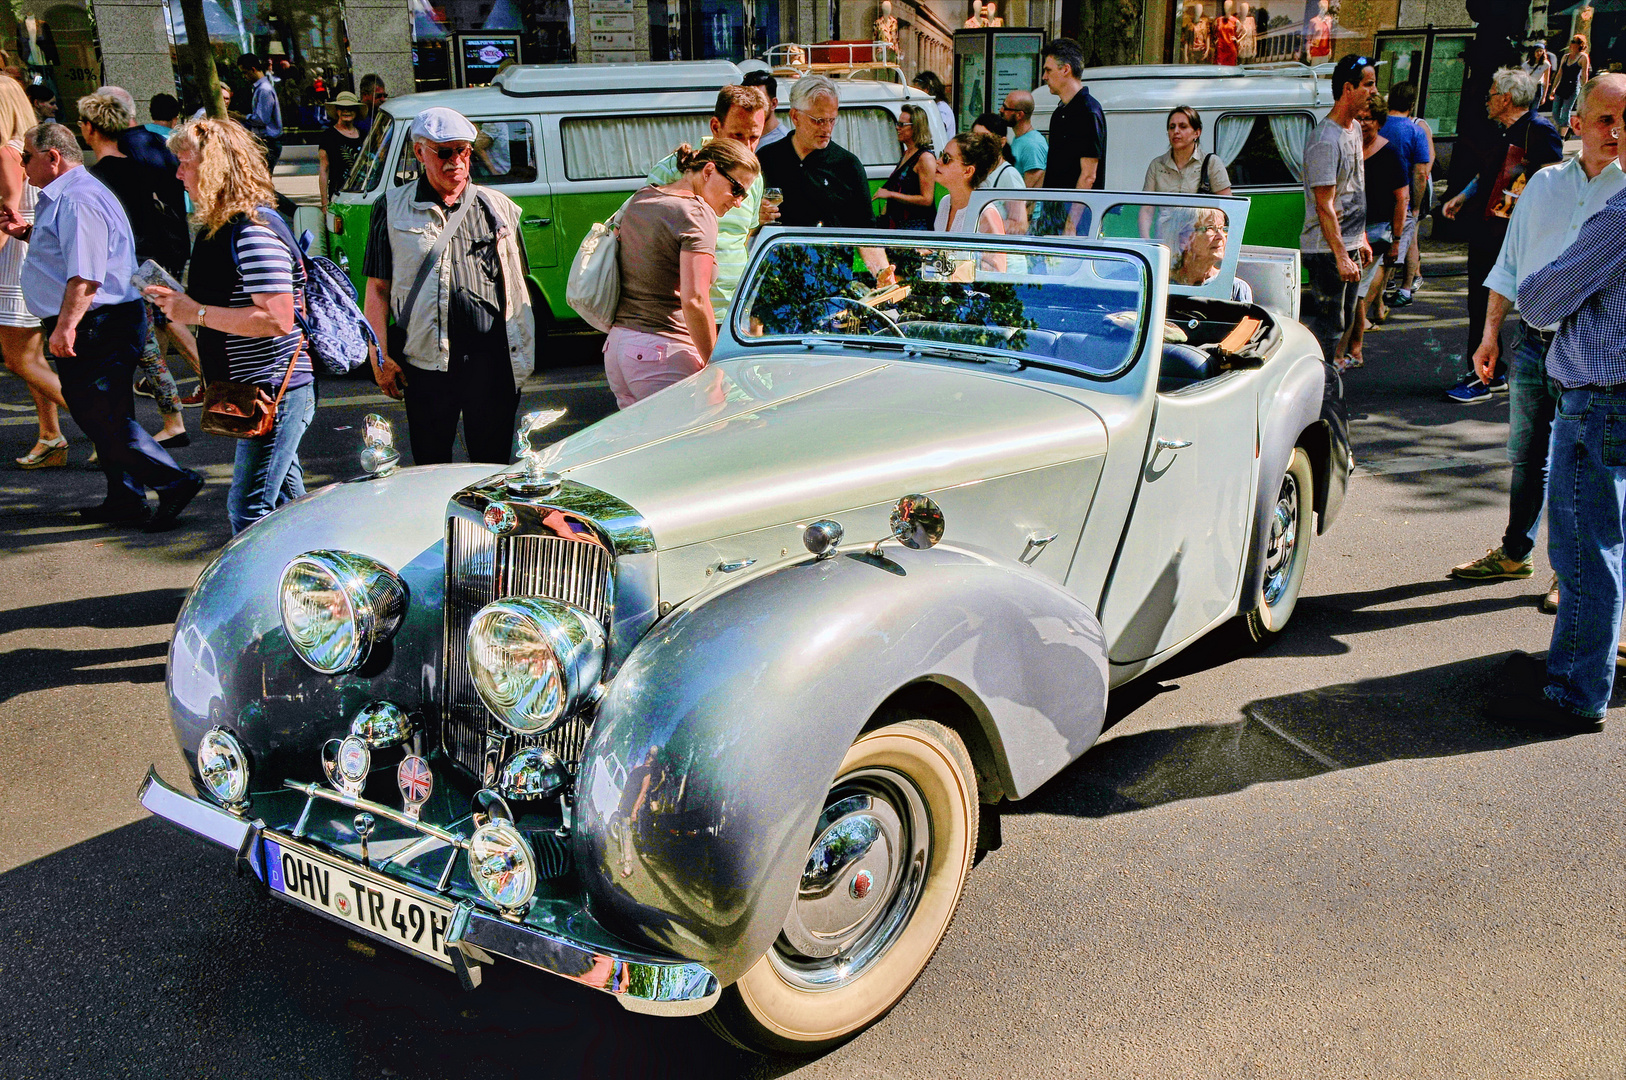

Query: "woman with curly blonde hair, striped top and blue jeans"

xmin=148 ymin=119 xmax=315 ymax=532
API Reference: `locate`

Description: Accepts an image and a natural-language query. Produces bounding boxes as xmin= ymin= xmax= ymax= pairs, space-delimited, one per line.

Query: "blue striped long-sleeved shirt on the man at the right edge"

xmin=1519 ymin=184 xmax=1626 ymax=389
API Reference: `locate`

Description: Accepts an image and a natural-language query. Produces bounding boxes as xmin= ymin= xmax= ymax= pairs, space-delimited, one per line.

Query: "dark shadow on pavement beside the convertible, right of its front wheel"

xmin=1006 ymin=650 xmax=1626 ymax=817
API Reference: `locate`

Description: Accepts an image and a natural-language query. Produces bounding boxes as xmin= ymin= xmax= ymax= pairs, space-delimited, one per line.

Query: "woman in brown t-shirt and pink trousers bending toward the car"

xmin=605 ymin=138 xmax=758 ymax=408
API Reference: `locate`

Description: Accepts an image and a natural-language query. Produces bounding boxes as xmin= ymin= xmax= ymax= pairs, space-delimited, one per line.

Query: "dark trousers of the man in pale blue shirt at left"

xmin=44 ymin=301 xmax=187 ymax=507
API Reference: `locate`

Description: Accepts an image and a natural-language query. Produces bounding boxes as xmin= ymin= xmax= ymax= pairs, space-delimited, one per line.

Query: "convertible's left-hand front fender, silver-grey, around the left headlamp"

xmin=166 ymin=465 xmax=493 ymax=790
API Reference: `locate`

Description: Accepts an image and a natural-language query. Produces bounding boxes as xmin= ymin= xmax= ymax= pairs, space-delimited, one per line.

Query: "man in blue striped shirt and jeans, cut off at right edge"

xmin=1491 ymin=109 xmax=1626 ymax=735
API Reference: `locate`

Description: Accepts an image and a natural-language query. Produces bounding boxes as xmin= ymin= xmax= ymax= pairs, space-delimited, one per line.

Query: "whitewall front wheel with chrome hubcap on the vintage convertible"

xmin=706 ymin=721 xmax=977 ymax=1054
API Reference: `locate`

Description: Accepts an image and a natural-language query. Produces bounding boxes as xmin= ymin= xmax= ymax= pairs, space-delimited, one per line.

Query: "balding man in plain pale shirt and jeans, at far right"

xmin=1450 ymin=73 xmax=1626 ymax=595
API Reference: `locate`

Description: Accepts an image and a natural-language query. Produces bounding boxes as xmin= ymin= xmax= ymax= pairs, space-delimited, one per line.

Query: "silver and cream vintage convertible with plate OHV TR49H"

xmin=140 ymin=192 xmax=1350 ymax=1051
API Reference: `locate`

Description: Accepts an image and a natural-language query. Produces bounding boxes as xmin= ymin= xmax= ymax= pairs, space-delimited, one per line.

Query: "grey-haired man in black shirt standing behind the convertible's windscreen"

xmin=756 ymin=75 xmax=875 ymax=229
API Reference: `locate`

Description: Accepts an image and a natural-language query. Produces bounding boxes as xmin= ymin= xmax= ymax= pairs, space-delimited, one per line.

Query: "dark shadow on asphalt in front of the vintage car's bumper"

xmin=0 ymin=818 xmax=798 ymax=1080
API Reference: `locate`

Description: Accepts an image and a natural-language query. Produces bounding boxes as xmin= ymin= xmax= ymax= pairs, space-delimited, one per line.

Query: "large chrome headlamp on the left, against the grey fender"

xmin=278 ymin=551 xmax=407 ymax=675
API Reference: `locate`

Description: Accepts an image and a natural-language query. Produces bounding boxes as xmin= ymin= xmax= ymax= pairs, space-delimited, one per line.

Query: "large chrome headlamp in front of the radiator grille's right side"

xmin=468 ymin=597 xmax=605 ymax=735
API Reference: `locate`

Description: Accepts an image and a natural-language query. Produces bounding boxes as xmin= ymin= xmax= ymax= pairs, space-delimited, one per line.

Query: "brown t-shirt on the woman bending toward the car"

xmin=615 ymin=187 xmax=717 ymax=338
